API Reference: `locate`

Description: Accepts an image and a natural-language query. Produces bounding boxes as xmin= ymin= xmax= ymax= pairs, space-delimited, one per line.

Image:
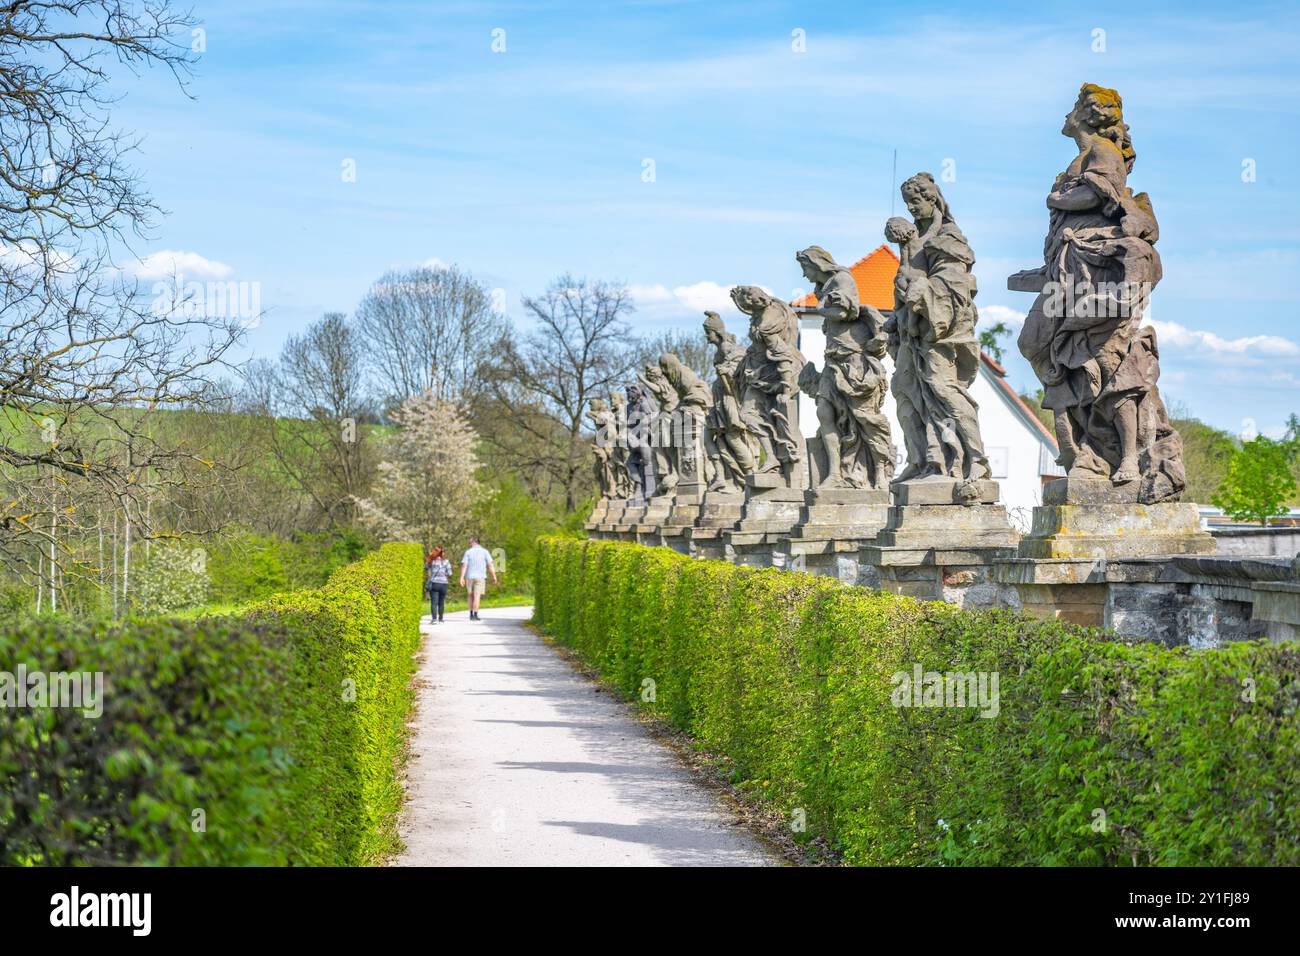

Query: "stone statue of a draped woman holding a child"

xmin=885 ymin=173 xmax=991 ymax=481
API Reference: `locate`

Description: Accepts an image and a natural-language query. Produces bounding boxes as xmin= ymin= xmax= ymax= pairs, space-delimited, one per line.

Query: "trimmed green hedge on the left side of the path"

xmin=0 ymin=545 xmax=423 ymax=865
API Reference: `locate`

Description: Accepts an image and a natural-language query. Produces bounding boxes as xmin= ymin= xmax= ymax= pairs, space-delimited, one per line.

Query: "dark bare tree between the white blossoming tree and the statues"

xmin=477 ymin=276 xmax=636 ymax=511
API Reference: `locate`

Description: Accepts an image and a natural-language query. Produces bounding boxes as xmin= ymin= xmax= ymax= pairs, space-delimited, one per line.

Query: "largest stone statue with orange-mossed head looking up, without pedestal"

xmin=1008 ymin=83 xmax=1187 ymax=503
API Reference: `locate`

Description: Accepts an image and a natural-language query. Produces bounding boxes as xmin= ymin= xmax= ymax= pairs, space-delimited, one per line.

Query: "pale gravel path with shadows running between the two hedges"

xmin=397 ymin=607 xmax=779 ymax=866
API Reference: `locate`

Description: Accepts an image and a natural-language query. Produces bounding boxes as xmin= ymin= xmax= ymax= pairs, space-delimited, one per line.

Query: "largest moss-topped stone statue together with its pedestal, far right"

xmin=1002 ymin=83 xmax=1214 ymax=567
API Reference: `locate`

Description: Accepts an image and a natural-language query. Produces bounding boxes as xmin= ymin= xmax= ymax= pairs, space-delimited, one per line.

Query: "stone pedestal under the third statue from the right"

xmin=777 ymin=488 xmax=889 ymax=584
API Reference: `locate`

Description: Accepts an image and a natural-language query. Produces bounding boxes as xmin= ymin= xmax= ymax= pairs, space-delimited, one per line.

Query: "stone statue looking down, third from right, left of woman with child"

xmin=794 ymin=246 xmax=894 ymax=489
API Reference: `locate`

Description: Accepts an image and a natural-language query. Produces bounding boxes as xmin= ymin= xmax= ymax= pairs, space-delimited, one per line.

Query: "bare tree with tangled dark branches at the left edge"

xmin=0 ymin=0 xmax=239 ymax=597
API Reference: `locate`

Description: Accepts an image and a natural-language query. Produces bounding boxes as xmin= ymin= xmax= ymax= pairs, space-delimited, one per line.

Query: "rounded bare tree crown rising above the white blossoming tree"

xmin=356 ymin=265 xmax=507 ymax=405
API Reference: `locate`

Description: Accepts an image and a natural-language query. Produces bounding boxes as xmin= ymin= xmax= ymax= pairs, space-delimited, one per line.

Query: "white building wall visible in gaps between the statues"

xmin=800 ymin=320 xmax=1050 ymax=531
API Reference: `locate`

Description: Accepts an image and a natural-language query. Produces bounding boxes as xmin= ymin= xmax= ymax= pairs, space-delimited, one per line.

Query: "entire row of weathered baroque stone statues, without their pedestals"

xmin=588 ymin=85 xmax=1186 ymax=515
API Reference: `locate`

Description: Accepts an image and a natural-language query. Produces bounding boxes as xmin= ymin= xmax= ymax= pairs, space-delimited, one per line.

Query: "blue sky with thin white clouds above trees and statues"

xmin=116 ymin=0 xmax=1300 ymax=432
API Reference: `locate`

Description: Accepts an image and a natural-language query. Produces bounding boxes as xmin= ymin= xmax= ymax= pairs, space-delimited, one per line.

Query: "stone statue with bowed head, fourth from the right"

xmin=731 ymin=285 xmax=805 ymax=488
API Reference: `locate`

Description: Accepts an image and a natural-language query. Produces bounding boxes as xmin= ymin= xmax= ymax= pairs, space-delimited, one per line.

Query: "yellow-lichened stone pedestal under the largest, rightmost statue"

xmin=1017 ymin=479 xmax=1214 ymax=561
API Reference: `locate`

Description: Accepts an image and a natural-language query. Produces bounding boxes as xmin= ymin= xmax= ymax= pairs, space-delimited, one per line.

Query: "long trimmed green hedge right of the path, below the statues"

xmin=534 ymin=538 xmax=1300 ymax=866
